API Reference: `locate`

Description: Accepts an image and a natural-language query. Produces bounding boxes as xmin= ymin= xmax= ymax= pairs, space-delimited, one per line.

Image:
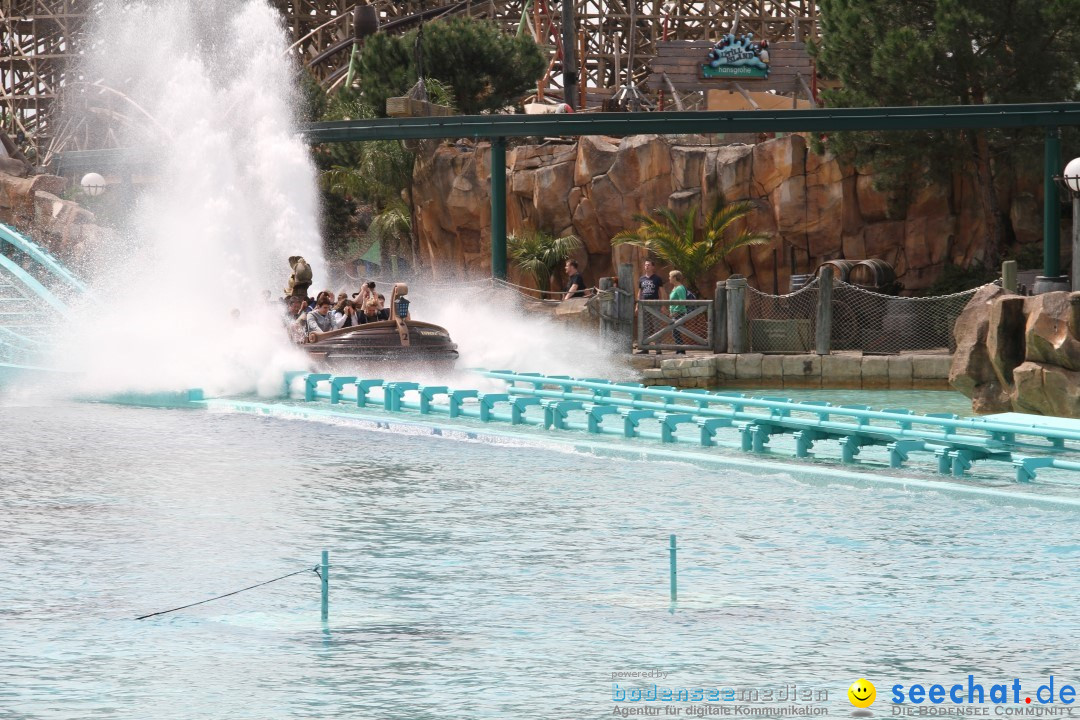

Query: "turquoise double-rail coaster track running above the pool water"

xmin=272 ymin=370 xmax=1080 ymax=483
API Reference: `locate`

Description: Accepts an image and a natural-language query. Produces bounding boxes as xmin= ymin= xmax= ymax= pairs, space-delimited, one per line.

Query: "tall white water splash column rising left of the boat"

xmin=50 ymin=0 xmax=324 ymax=392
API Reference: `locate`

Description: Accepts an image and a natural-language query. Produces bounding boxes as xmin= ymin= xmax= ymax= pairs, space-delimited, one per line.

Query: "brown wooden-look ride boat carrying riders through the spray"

xmin=300 ymin=283 xmax=458 ymax=370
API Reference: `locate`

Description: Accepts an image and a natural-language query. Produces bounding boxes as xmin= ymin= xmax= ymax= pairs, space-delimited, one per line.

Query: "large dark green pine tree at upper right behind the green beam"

xmin=811 ymin=0 xmax=1080 ymax=269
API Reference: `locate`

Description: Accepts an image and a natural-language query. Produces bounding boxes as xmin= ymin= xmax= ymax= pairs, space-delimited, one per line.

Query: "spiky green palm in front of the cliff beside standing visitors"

xmin=611 ymin=201 xmax=772 ymax=295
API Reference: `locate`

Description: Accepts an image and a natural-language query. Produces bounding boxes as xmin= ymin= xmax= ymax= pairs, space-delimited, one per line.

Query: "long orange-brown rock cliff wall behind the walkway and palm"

xmin=414 ymin=135 xmax=1042 ymax=291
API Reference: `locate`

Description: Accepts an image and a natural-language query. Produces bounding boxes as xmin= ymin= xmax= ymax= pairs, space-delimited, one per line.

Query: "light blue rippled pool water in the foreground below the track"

xmin=0 ymin=405 xmax=1080 ymax=718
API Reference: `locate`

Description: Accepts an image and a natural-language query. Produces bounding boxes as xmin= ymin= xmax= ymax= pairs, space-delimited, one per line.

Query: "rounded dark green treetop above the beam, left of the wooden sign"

xmin=356 ymin=17 xmax=548 ymax=116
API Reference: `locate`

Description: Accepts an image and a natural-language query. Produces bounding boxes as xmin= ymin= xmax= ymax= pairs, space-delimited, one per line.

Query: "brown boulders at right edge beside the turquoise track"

xmin=949 ymin=287 xmax=1080 ymax=418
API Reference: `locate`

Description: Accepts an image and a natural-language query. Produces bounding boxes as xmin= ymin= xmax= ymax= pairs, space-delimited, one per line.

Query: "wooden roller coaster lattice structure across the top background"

xmin=0 ymin=0 xmax=818 ymax=159
